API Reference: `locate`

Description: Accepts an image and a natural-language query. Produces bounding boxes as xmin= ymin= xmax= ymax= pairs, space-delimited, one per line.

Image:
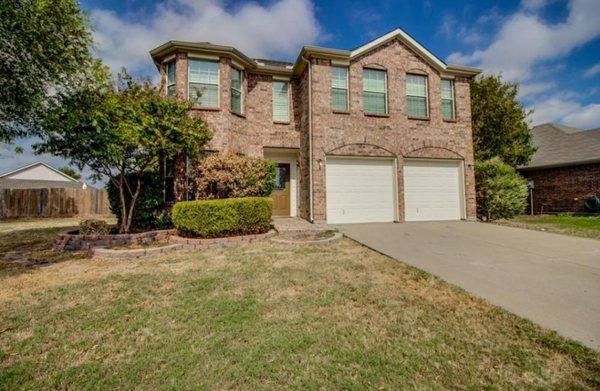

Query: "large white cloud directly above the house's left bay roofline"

xmin=91 ymin=0 xmax=321 ymax=72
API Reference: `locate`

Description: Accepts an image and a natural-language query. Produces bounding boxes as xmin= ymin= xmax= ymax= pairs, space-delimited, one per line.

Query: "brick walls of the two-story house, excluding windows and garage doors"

xmin=158 ymin=34 xmax=476 ymax=221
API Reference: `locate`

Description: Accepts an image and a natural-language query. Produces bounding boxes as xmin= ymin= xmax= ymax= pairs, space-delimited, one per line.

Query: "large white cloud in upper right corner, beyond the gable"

xmin=448 ymin=0 xmax=600 ymax=81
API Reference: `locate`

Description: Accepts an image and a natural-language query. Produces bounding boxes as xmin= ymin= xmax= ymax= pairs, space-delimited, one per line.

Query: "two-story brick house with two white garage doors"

xmin=150 ymin=29 xmax=480 ymax=223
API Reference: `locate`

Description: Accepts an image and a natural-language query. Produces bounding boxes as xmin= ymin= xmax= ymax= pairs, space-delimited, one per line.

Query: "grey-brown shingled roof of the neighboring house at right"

xmin=520 ymin=124 xmax=600 ymax=170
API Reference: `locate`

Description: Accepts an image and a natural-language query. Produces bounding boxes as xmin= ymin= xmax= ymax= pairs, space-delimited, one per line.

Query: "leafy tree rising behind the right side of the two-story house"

xmin=471 ymin=75 xmax=535 ymax=167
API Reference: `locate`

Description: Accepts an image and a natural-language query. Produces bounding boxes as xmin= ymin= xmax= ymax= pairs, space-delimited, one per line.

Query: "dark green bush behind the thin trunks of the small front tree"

xmin=106 ymin=171 xmax=173 ymax=231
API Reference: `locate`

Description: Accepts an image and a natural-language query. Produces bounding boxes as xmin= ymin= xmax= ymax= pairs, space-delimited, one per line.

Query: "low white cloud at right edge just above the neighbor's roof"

xmin=531 ymin=95 xmax=600 ymax=129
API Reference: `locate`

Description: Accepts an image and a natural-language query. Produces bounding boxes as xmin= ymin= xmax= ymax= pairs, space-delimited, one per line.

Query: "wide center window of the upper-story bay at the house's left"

xmin=188 ymin=59 xmax=219 ymax=107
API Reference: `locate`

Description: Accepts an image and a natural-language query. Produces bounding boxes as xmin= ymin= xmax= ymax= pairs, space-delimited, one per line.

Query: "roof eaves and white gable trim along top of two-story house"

xmin=150 ymin=28 xmax=481 ymax=77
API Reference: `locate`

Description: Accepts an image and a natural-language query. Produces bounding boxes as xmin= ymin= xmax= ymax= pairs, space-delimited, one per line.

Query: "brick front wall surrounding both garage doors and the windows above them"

xmin=312 ymin=40 xmax=476 ymax=221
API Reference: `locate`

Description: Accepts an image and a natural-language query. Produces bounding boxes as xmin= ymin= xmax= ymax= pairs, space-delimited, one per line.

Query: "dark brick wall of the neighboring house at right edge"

xmin=521 ymin=164 xmax=600 ymax=214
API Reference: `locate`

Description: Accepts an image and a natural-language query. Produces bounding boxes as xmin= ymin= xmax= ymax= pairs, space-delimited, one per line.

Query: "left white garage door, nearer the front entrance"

xmin=325 ymin=157 xmax=396 ymax=224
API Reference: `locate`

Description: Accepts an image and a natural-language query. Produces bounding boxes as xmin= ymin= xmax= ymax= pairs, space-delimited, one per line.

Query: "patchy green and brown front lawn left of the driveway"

xmin=0 ymin=222 xmax=600 ymax=390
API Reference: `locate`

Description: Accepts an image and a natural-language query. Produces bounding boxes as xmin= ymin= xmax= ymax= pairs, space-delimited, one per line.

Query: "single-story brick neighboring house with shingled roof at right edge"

xmin=518 ymin=124 xmax=600 ymax=214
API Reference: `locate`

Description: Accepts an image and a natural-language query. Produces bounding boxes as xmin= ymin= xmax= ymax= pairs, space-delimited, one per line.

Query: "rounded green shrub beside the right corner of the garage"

xmin=475 ymin=157 xmax=527 ymax=220
